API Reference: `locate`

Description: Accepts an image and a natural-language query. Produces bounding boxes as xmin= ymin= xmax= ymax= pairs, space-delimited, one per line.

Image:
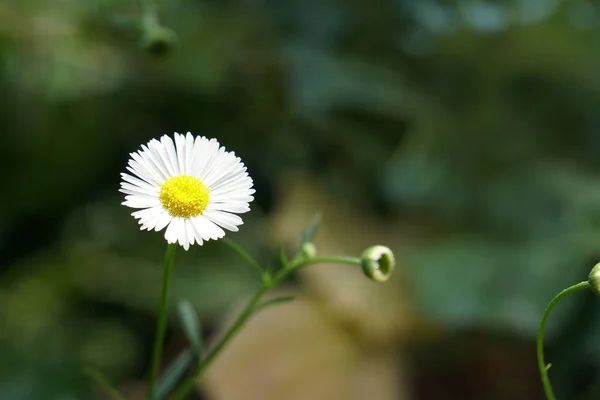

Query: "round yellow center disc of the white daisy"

xmin=160 ymin=175 xmax=210 ymax=218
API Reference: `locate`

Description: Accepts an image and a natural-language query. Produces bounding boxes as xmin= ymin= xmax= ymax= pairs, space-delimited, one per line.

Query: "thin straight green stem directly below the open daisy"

xmin=148 ymin=243 xmax=177 ymax=400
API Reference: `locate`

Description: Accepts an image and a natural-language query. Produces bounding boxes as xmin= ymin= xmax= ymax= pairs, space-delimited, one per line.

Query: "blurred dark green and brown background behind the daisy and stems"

xmin=0 ymin=0 xmax=600 ymax=400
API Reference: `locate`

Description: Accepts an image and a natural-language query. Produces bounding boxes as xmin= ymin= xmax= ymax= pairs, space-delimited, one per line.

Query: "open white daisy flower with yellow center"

xmin=119 ymin=132 xmax=255 ymax=250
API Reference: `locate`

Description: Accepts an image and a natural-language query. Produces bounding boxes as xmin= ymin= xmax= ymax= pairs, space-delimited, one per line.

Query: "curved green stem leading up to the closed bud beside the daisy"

xmin=166 ymin=256 xmax=360 ymax=400
